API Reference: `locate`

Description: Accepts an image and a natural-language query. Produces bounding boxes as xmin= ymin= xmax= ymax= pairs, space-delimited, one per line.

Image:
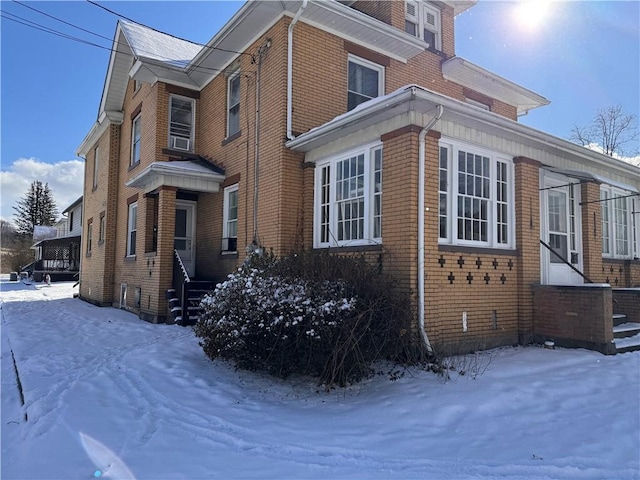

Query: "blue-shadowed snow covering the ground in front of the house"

xmin=0 ymin=278 xmax=640 ymax=479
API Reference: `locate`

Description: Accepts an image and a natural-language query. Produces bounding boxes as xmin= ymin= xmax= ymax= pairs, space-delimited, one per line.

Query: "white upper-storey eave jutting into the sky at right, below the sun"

xmin=442 ymin=57 xmax=549 ymax=115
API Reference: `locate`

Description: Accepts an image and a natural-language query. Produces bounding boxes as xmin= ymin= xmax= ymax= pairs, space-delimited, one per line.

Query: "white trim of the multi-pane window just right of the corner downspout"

xmin=438 ymin=137 xmax=516 ymax=250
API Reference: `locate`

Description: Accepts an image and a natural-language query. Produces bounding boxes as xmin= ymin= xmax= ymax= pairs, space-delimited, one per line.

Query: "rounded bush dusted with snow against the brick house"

xmin=195 ymin=252 xmax=412 ymax=386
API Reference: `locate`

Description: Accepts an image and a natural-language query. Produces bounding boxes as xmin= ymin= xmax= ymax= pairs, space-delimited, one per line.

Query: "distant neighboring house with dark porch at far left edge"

xmin=27 ymin=197 xmax=82 ymax=282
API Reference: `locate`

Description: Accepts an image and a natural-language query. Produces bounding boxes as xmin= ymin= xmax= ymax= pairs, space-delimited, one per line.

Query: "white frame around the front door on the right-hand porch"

xmin=540 ymin=170 xmax=584 ymax=285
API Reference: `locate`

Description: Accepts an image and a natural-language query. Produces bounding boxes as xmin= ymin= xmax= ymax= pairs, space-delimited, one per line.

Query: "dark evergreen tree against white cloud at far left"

xmin=13 ymin=180 xmax=58 ymax=236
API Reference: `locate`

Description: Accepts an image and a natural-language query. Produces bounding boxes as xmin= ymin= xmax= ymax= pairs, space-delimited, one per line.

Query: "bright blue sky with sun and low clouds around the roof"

xmin=0 ymin=0 xmax=640 ymax=223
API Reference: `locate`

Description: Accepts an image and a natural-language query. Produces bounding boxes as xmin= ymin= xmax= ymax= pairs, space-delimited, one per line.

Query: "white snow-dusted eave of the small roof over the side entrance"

xmin=126 ymin=160 xmax=225 ymax=193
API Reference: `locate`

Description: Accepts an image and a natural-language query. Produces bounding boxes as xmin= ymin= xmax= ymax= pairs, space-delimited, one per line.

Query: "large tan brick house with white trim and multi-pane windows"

xmin=78 ymin=0 xmax=640 ymax=353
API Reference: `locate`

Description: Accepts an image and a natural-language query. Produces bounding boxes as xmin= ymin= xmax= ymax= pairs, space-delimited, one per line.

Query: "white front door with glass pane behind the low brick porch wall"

xmin=540 ymin=172 xmax=584 ymax=285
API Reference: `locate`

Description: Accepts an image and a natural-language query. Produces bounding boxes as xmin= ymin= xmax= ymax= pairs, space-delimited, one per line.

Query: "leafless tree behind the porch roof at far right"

xmin=569 ymin=105 xmax=640 ymax=157
